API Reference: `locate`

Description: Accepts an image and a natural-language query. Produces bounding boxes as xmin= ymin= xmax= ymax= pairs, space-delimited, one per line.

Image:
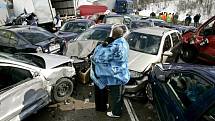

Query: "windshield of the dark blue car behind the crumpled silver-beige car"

xmin=60 ymin=22 xmax=87 ymax=33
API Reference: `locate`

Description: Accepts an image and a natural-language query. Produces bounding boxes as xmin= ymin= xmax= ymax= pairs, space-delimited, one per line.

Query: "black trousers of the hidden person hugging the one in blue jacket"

xmin=95 ymin=85 xmax=108 ymax=112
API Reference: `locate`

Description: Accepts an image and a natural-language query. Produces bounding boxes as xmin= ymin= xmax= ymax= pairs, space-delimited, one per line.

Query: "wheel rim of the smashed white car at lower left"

xmin=57 ymin=82 xmax=72 ymax=97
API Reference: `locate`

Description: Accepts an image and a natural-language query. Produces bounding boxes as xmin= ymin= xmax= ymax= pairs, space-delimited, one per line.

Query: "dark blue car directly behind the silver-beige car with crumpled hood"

xmin=55 ymin=19 xmax=95 ymax=42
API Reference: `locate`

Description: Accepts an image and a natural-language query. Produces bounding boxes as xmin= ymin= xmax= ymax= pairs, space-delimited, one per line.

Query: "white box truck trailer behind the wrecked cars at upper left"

xmin=7 ymin=0 xmax=75 ymax=31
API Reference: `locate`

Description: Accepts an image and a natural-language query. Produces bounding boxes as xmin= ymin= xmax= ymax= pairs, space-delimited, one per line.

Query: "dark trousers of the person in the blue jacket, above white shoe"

xmin=109 ymin=85 xmax=124 ymax=116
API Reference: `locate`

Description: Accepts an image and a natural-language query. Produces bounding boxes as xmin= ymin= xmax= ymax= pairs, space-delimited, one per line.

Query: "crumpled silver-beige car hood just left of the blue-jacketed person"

xmin=66 ymin=40 xmax=98 ymax=58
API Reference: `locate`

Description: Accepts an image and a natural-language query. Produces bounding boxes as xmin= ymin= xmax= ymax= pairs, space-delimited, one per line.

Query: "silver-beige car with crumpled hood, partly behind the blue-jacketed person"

xmin=65 ymin=24 xmax=129 ymax=84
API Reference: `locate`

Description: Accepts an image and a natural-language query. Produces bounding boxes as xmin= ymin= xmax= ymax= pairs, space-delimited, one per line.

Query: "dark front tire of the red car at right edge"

xmin=180 ymin=45 xmax=198 ymax=63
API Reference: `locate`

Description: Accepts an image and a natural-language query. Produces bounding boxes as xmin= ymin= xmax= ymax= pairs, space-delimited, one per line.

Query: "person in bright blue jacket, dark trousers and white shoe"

xmin=90 ymin=27 xmax=130 ymax=117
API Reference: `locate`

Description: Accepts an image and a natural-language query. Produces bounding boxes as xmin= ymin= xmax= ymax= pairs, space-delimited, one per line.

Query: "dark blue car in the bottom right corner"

xmin=149 ymin=64 xmax=215 ymax=121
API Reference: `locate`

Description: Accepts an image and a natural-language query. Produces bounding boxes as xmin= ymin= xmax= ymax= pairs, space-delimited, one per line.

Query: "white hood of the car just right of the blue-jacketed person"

xmin=128 ymin=50 xmax=158 ymax=72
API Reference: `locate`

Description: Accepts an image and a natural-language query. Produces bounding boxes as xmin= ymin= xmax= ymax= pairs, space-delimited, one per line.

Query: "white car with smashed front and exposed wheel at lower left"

xmin=0 ymin=53 xmax=75 ymax=121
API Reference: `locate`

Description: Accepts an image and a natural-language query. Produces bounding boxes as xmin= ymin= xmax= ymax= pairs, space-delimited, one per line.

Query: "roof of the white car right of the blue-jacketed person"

xmin=133 ymin=27 xmax=173 ymax=36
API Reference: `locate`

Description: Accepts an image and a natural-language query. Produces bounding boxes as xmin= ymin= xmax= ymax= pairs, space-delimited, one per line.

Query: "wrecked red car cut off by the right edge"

xmin=181 ymin=16 xmax=215 ymax=65
